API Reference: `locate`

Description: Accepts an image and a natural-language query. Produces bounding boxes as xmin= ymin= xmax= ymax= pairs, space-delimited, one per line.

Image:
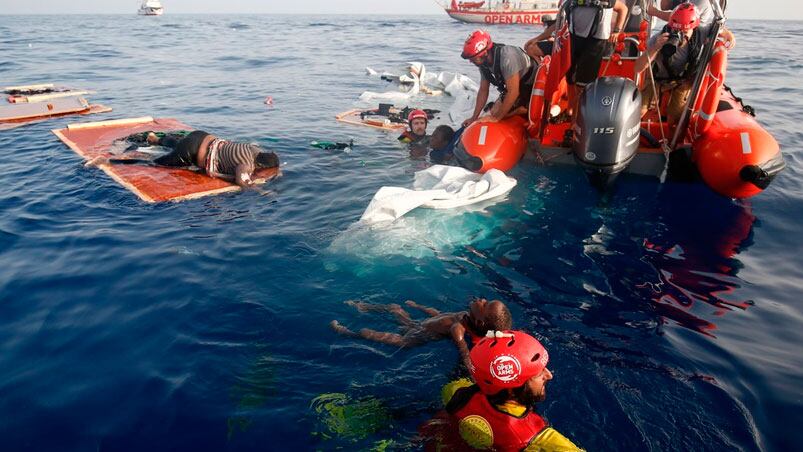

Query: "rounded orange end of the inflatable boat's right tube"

xmin=692 ymin=96 xmax=786 ymax=198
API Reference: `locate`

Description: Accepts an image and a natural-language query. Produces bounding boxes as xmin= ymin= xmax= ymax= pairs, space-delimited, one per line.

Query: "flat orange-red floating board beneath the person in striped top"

xmin=53 ymin=117 xmax=279 ymax=202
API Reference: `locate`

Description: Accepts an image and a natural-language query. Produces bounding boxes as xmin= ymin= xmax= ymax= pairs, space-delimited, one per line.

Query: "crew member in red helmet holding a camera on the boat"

xmin=635 ymin=3 xmax=705 ymax=124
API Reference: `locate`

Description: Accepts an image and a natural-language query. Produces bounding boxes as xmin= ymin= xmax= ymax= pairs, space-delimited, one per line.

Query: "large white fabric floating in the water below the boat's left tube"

xmin=360 ymin=165 xmax=516 ymax=224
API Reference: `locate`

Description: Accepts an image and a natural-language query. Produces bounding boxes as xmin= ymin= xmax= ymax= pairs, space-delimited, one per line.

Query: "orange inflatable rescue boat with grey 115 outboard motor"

xmin=455 ymin=2 xmax=785 ymax=198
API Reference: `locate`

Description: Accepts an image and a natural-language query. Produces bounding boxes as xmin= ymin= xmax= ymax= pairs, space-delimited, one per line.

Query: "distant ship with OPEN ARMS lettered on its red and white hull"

xmin=441 ymin=0 xmax=558 ymax=25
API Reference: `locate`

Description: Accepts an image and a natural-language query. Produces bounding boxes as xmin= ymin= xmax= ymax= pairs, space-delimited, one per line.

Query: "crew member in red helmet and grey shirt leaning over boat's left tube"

xmin=462 ymin=30 xmax=538 ymax=126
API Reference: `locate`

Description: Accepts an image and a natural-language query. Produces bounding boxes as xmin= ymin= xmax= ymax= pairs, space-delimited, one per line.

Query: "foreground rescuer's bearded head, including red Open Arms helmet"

xmin=470 ymin=330 xmax=552 ymax=404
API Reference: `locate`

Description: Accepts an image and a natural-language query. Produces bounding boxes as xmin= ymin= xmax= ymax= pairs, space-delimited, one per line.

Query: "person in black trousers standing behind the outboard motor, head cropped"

xmin=565 ymin=0 xmax=628 ymax=115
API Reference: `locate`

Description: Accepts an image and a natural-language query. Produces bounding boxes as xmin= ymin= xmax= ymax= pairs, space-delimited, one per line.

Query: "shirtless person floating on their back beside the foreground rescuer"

xmin=330 ymin=298 xmax=513 ymax=369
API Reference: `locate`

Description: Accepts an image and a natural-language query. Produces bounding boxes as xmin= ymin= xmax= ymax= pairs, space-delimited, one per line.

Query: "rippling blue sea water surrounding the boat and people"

xmin=0 ymin=15 xmax=803 ymax=451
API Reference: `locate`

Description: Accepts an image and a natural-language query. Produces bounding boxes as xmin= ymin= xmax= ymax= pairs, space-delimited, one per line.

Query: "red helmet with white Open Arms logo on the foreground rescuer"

xmin=470 ymin=330 xmax=549 ymax=395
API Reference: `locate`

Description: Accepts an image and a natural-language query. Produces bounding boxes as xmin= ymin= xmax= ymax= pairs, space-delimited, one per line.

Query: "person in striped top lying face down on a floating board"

xmin=87 ymin=130 xmax=279 ymax=187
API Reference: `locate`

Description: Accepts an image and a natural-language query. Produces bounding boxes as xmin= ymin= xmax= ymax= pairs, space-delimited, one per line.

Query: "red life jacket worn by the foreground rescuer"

xmin=446 ymin=385 xmax=548 ymax=451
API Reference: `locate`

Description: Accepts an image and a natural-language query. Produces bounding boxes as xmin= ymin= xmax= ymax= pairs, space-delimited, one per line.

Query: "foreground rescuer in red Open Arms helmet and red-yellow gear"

xmin=421 ymin=330 xmax=581 ymax=452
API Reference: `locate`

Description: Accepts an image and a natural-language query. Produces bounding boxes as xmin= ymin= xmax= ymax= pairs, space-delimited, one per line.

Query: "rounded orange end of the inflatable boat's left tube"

xmin=455 ymin=116 xmax=527 ymax=173
